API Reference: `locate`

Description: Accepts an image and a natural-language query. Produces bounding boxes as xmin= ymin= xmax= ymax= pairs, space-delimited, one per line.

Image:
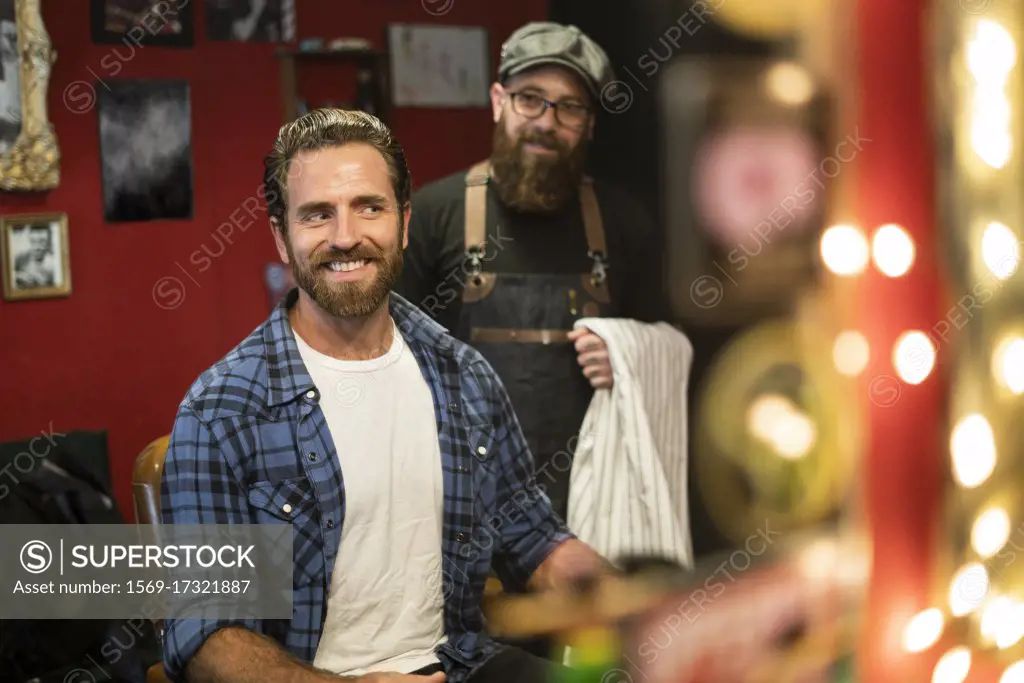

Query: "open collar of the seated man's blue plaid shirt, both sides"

xmin=263 ymin=288 xmax=455 ymax=405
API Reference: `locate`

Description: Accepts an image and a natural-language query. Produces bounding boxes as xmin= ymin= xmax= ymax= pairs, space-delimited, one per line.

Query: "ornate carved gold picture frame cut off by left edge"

xmin=0 ymin=0 xmax=60 ymax=191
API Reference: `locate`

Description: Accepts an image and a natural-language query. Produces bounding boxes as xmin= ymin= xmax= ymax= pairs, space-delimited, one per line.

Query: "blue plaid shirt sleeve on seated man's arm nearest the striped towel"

xmin=484 ymin=364 xmax=575 ymax=587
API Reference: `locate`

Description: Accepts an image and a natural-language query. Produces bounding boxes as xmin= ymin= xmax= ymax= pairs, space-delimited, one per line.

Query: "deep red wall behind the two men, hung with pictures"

xmin=0 ymin=0 xmax=547 ymax=515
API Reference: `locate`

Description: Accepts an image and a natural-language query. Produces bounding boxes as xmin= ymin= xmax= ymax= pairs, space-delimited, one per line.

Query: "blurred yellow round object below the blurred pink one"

xmin=694 ymin=323 xmax=856 ymax=544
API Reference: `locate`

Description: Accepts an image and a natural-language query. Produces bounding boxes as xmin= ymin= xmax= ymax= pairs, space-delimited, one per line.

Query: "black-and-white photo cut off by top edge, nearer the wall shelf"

xmin=206 ymin=0 xmax=295 ymax=43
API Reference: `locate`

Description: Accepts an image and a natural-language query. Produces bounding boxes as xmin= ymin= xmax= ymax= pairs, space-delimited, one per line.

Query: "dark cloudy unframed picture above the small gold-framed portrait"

xmin=96 ymin=80 xmax=193 ymax=222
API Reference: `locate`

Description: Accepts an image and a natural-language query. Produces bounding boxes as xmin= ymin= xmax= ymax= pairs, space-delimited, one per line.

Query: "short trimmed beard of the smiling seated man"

xmin=286 ymin=228 xmax=403 ymax=317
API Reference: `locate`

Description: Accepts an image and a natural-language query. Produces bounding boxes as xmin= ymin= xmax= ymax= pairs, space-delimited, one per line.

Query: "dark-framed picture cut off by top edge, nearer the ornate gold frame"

xmin=91 ymin=0 xmax=196 ymax=47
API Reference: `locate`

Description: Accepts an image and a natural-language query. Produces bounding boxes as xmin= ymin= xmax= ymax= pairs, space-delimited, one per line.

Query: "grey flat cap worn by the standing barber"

xmin=498 ymin=22 xmax=614 ymax=99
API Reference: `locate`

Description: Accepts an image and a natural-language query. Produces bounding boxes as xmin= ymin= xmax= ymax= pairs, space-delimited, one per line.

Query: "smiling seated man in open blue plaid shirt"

xmin=161 ymin=110 xmax=602 ymax=683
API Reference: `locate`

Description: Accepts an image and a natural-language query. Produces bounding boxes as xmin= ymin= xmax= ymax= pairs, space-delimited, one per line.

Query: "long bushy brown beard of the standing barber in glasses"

xmin=490 ymin=121 xmax=588 ymax=212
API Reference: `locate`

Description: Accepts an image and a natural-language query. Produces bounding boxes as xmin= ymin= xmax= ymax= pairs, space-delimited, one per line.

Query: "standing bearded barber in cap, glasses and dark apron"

xmin=396 ymin=23 xmax=669 ymax=517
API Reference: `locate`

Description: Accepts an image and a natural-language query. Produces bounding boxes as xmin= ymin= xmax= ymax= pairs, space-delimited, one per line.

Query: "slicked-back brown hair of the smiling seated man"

xmin=263 ymin=109 xmax=413 ymax=232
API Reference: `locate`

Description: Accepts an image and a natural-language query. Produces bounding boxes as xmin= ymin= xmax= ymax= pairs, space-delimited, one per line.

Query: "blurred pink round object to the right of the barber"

xmin=693 ymin=126 xmax=823 ymax=248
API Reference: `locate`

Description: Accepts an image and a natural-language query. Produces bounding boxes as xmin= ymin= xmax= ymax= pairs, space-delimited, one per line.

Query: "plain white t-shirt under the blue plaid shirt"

xmin=295 ymin=322 xmax=445 ymax=676
